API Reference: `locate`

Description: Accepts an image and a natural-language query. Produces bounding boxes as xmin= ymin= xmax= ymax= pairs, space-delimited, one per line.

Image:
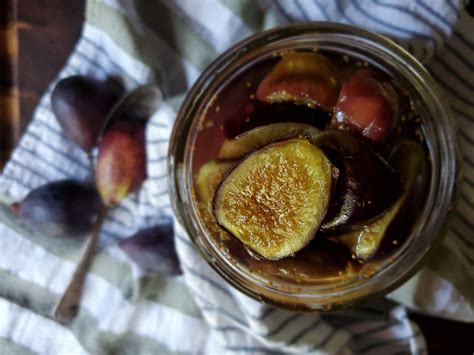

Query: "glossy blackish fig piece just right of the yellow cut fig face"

xmin=315 ymin=130 xmax=402 ymax=235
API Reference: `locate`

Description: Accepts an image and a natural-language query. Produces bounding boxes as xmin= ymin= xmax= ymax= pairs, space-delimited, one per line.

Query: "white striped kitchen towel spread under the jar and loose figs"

xmin=0 ymin=0 xmax=474 ymax=354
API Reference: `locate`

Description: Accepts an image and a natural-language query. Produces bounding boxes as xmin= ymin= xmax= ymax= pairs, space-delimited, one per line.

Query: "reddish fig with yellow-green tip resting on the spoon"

xmin=96 ymin=121 xmax=146 ymax=206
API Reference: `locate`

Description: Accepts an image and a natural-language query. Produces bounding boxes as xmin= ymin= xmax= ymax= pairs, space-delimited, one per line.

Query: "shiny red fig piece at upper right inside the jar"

xmin=334 ymin=69 xmax=399 ymax=142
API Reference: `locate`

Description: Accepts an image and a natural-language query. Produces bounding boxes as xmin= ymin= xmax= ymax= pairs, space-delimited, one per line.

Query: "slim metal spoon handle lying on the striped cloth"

xmin=53 ymin=204 xmax=108 ymax=322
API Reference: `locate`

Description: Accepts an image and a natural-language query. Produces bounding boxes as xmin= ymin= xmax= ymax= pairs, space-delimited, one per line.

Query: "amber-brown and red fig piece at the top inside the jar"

xmin=256 ymin=52 xmax=341 ymax=110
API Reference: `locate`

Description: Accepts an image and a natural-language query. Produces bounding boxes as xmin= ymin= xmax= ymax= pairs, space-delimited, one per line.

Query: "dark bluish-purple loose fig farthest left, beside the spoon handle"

xmin=12 ymin=180 xmax=101 ymax=237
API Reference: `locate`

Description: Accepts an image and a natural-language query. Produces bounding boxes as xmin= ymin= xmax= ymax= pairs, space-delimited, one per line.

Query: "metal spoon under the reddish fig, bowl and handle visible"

xmin=53 ymin=84 xmax=162 ymax=322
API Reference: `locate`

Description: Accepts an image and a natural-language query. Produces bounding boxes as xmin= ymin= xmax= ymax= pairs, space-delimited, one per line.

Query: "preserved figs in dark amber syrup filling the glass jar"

xmin=192 ymin=51 xmax=429 ymax=284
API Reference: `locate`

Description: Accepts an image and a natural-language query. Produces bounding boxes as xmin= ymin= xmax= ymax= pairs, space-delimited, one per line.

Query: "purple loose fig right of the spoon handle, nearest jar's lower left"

xmin=119 ymin=224 xmax=182 ymax=276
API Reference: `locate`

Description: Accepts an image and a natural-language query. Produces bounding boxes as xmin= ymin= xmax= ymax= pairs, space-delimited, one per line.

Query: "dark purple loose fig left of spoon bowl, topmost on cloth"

xmin=51 ymin=75 xmax=121 ymax=152
